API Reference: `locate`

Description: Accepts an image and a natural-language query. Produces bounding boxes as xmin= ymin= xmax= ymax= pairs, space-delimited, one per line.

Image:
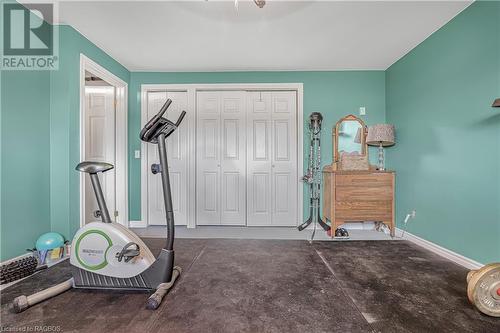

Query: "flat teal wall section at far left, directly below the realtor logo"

xmin=0 ymin=71 xmax=50 ymax=260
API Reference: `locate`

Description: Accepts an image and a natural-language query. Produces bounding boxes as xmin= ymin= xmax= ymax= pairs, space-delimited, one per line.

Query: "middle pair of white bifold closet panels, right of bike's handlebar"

xmin=196 ymin=91 xmax=246 ymax=225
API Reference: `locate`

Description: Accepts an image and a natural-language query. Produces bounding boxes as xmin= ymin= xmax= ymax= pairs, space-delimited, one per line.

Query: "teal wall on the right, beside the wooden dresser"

xmin=386 ymin=2 xmax=500 ymax=263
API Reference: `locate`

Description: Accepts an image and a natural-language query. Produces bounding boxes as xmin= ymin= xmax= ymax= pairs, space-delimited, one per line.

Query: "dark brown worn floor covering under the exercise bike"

xmin=1 ymin=239 xmax=500 ymax=332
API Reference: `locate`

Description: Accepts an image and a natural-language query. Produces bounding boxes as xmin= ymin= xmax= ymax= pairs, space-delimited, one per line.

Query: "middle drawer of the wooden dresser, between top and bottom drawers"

xmin=335 ymin=184 xmax=392 ymax=201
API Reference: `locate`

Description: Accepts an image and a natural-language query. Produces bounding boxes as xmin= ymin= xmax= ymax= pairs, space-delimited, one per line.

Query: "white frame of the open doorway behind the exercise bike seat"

xmin=79 ymin=53 xmax=129 ymax=227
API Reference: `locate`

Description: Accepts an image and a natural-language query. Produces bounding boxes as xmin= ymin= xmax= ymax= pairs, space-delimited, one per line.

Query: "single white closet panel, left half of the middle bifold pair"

xmin=196 ymin=91 xmax=221 ymax=225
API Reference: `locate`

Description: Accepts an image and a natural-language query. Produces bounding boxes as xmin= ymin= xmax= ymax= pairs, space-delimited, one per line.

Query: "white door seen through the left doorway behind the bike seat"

xmin=84 ymin=86 xmax=116 ymax=223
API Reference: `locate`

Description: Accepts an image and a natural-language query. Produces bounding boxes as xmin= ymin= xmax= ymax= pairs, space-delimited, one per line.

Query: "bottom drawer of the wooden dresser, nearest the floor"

xmin=335 ymin=201 xmax=392 ymax=221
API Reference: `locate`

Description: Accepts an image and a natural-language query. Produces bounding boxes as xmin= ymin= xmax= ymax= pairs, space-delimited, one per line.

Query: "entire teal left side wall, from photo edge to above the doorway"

xmin=0 ymin=20 xmax=130 ymax=260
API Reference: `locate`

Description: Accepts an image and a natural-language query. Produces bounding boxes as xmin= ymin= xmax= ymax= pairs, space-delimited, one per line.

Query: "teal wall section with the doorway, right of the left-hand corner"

xmin=50 ymin=25 xmax=130 ymax=238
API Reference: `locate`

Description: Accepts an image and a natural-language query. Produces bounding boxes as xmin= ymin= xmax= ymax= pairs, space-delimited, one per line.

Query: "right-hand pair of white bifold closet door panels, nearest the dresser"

xmin=247 ymin=91 xmax=298 ymax=226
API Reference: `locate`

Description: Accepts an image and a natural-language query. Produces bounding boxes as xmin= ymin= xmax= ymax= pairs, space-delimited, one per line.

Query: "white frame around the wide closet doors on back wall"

xmin=141 ymin=83 xmax=304 ymax=228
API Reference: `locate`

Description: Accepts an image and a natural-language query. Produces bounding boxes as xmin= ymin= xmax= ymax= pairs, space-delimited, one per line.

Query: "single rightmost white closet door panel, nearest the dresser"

xmin=271 ymin=91 xmax=299 ymax=226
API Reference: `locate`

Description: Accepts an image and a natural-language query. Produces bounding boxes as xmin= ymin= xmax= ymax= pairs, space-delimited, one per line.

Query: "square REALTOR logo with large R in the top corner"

xmin=0 ymin=3 xmax=58 ymax=70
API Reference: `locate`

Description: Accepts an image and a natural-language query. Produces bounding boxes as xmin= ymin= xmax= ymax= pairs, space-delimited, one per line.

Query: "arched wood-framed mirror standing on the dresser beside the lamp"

xmin=332 ymin=114 xmax=367 ymax=163
